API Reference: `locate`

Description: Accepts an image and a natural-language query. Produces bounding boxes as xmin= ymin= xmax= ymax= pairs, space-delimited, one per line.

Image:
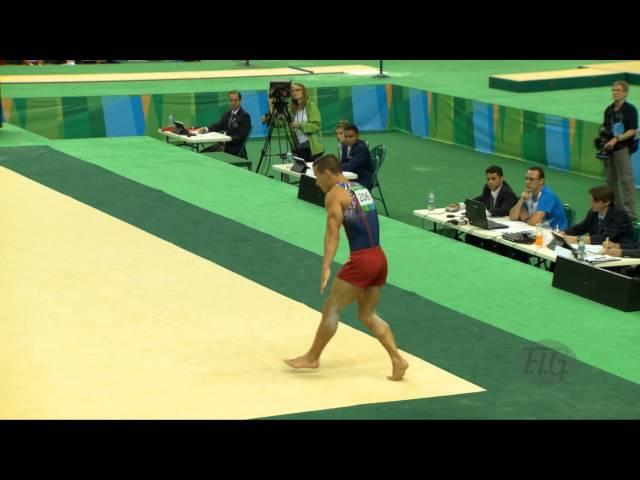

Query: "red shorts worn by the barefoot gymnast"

xmin=337 ymin=247 xmax=387 ymax=288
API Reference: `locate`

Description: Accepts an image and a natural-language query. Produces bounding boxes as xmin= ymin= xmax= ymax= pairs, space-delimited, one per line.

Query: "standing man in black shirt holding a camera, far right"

xmin=601 ymin=80 xmax=638 ymax=220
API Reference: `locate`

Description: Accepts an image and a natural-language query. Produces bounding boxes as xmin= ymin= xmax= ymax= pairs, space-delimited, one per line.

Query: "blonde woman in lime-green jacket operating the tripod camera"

xmin=263 ymin=83 xmax=324 ymax=162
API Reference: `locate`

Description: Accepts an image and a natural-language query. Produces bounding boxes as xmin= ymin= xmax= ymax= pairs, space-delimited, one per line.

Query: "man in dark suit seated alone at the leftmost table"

xmin=199 ymin=90 xmax=251 ymax=156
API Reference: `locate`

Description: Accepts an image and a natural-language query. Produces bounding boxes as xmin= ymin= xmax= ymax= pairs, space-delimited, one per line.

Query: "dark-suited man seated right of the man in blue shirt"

xmin=565 ymin=186 xmax=633 ymax=245
